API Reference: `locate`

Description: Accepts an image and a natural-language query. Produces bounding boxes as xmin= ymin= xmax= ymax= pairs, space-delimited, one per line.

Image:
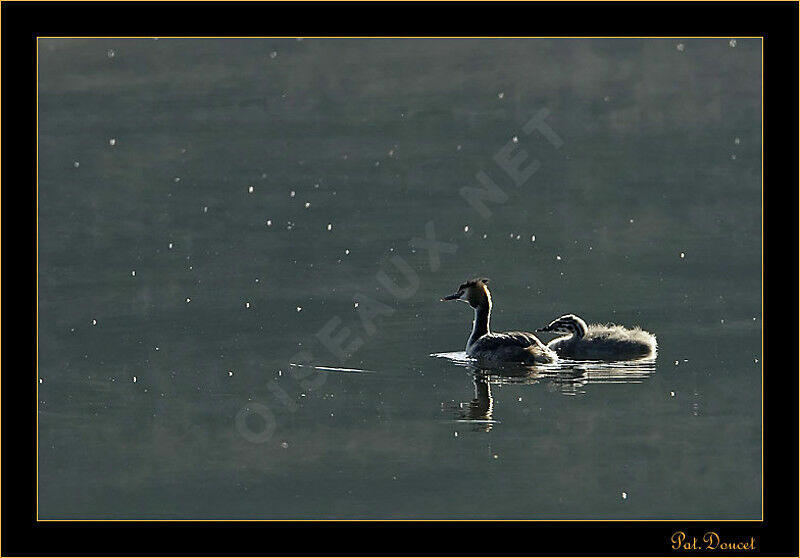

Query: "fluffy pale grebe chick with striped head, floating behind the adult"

xmin=536 ymin=314 xmax=657 ymax=360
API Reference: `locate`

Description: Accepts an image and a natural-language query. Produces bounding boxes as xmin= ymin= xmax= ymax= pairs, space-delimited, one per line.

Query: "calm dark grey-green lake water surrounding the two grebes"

xmin=37 ymin=39 xmax=762 ymax=519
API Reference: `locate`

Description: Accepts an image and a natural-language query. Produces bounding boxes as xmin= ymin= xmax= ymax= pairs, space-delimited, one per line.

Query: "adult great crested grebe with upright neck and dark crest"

xmin=442 ymin=279 xmax=558 ymax=364
